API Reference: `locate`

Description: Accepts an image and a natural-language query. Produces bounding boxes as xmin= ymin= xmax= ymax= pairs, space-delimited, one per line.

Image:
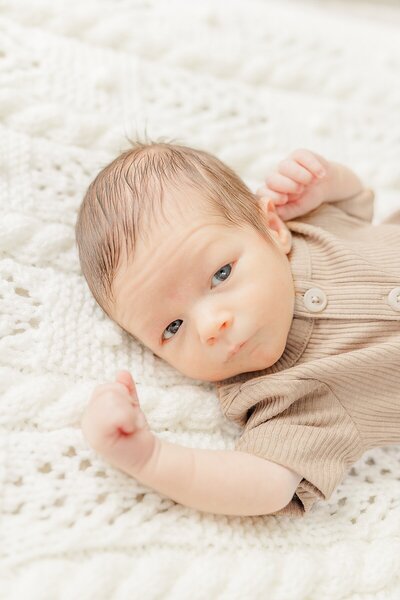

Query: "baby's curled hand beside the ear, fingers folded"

xmin=256 ymin=148 xmax=332 ymax=221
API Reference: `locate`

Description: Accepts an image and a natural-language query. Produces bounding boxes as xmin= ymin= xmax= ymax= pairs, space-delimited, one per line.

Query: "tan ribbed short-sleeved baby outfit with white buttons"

xmin=217 ymin=189 xmax=400 ymax=516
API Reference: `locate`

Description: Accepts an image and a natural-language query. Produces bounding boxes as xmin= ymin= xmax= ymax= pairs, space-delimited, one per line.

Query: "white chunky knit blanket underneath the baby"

xmin=0 ymin=0 xmax=400 ymax=600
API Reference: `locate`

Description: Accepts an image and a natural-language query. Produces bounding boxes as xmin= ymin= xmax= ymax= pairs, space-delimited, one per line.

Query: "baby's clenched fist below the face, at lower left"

xmin=81 ymin=371 xmax=156 ymax=476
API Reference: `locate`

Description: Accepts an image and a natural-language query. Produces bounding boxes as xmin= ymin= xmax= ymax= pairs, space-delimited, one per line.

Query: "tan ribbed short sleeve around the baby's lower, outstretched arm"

xmin=220 ymin=376 xmax=363 ymax=516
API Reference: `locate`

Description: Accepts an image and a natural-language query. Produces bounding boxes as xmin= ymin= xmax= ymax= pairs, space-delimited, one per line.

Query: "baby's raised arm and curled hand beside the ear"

xmin=256 ymin=149 xmax=364 ymax=221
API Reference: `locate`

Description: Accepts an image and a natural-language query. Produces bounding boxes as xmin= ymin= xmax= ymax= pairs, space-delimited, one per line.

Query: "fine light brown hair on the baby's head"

xmin=75 ymin=141 xmax=273 ymax=319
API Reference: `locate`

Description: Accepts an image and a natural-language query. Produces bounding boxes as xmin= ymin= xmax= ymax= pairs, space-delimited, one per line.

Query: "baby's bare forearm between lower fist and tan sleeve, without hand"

xmin=132 ymin=438 xmax=289 ymax=516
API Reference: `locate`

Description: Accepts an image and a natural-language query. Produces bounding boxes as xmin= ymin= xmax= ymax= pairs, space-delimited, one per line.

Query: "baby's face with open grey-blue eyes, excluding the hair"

xmin=113 ymin=186 xmax=294 ymax=381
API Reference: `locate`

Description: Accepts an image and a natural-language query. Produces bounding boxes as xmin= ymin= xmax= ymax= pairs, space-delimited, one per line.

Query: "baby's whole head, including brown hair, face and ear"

xmin=76 ymin=142 xmax=294 ymax=381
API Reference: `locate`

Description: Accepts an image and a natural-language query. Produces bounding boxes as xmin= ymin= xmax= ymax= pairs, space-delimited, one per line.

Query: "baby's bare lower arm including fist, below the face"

xmin=82 ymin=372 xmax=302 ymax=516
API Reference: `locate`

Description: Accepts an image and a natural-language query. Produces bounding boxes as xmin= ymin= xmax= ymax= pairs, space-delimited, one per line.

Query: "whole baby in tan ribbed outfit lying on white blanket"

xmin=76 ymin=143 xmax=400 ymax=516
